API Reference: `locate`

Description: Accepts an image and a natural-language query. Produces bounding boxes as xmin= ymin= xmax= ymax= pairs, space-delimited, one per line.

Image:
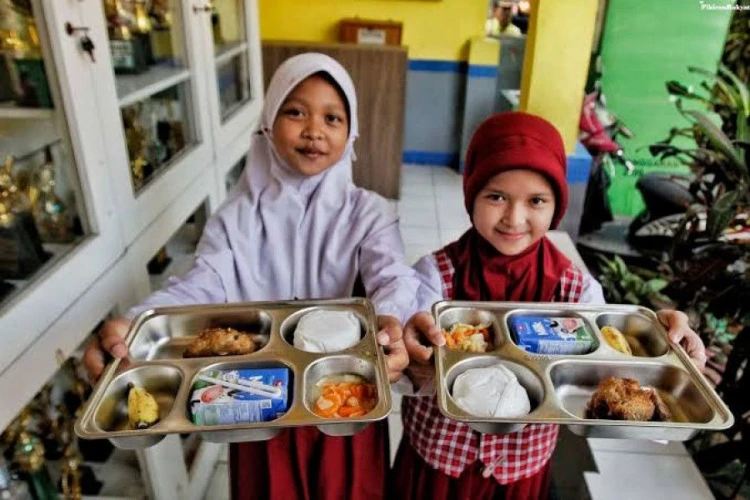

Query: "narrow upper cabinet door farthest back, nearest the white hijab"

xmin=202 ymin=0 xmax=263 ymax=151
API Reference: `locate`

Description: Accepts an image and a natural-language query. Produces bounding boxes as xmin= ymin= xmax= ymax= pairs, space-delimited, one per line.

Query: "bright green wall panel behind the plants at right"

xmin=602 ymin=0 xmax=731 ymax=215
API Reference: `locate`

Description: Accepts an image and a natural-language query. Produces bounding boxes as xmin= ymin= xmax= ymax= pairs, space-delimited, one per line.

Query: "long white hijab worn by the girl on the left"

xmin=198 ymin=53 xmax=396 ymax=302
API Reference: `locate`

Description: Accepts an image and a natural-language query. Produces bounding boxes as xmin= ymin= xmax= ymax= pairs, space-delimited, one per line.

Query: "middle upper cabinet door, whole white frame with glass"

xmin=85 ymin=0 xmax=212 ymax=244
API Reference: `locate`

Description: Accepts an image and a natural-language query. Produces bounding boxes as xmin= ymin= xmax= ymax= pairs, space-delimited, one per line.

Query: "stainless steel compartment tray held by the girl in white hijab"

xmin=75 ymin=299 xmax=392 ymax=449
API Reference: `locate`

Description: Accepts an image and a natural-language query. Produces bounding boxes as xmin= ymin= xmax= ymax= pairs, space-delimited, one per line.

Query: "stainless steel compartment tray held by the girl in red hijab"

xmin=433 ymin=301 xmax=734 ymax=441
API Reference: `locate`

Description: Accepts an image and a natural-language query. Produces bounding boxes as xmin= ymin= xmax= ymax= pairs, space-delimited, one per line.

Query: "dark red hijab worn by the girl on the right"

xmin=445 ymin=112 xmax=571 ymax=302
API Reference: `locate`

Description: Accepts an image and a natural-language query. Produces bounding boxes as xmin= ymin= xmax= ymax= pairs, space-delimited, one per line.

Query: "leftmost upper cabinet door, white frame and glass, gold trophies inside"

xmin=0 ymin=0 xmax=123 ymax=372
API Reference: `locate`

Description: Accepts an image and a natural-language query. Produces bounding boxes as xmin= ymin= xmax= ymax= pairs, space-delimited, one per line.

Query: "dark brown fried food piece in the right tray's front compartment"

xmin=586 ymin=377 xmax=671 ymax=422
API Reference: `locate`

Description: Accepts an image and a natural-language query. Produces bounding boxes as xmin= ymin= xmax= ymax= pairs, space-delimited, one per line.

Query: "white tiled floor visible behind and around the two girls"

xmin=198 ymin=166 xmax=712 ymax=500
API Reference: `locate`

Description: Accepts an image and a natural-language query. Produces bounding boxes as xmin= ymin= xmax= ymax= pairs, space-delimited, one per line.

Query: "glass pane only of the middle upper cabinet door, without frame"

xmin=103 ymin=0 xmax=198 ymax=194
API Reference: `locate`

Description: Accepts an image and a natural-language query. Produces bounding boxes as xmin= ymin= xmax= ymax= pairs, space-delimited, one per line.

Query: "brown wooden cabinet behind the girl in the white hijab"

xmin=263 ymin=41 xmax=407 ymax=199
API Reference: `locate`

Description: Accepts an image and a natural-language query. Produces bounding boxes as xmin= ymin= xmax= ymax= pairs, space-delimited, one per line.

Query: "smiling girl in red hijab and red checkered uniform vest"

xmin=392 ymin=113 xmax=705 ymax=500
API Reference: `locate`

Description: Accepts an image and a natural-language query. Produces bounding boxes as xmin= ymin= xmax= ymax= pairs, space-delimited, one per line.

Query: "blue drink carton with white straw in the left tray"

xmin=190 ymin=368 xmax=289 ymax=425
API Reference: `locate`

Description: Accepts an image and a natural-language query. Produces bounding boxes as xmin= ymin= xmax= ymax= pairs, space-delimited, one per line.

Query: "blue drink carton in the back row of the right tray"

xmin=509 ymin=316 xmax=595 ymax=354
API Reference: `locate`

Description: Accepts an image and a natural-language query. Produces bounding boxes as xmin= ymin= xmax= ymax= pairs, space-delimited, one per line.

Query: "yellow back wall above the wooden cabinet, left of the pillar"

xmin=259 ymin=0 xmax=487 ymax=61
